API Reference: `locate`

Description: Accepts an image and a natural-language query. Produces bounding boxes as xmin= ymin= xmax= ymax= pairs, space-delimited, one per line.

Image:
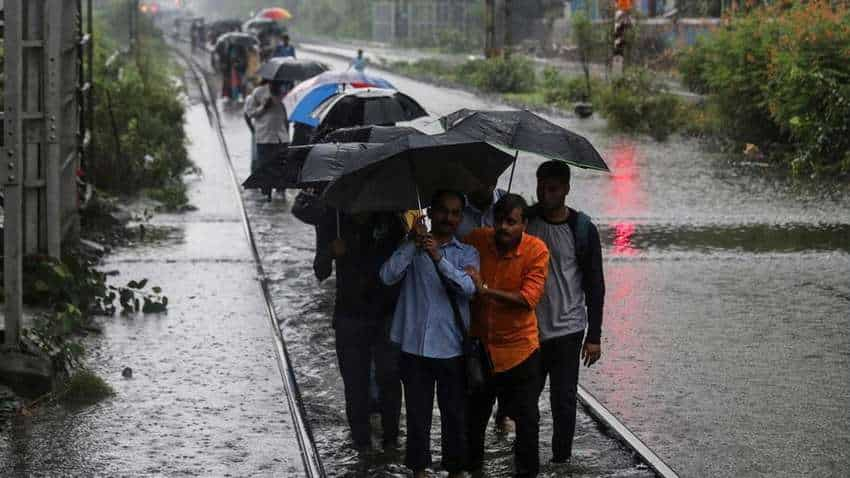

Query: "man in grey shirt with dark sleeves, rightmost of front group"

xmin=528 ymin=161 xmax=605 ymax=463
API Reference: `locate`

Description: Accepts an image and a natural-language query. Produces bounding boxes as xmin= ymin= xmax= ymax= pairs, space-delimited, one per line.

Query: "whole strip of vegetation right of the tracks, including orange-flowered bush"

xmin=389 ymin=0 xmax=850 ymax=177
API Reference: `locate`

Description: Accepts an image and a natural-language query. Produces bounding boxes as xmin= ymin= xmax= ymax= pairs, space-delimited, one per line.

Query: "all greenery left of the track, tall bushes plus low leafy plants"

xmin=0 ymin=0 xmax=185 ymax=414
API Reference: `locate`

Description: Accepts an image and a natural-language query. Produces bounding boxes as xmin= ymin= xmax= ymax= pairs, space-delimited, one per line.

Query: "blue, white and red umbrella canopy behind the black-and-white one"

xmin=283 ymin=71 xmax=395 ymax=120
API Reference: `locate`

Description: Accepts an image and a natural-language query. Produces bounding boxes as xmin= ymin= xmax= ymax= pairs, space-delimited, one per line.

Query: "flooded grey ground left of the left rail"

xmin=0 ymin=65 xmax=303 ymax=477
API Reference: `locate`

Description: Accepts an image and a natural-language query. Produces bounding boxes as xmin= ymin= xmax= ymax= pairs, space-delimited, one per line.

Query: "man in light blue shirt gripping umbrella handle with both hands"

xmin=380 ymin=191 xmax=479 ymax=478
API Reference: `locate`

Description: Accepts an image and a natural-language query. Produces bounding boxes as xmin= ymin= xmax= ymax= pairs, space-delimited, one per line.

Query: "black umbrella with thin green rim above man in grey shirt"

xmin=440 ymin=109 xmax=610 ymax=171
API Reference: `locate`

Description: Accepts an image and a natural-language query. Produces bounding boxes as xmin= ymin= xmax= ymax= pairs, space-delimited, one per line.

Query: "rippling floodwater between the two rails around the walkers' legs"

xmin=189 ymin=44 xmax=653 ymax=477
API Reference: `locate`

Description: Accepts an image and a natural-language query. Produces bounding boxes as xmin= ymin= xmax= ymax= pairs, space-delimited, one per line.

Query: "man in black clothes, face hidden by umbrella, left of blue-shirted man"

xmin=313 ymin=210 xmax=405 ymax=449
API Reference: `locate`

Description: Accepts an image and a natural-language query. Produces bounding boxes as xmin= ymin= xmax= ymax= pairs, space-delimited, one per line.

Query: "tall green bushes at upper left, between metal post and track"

xmin=86 ymin=1 xmax=191 ymax=203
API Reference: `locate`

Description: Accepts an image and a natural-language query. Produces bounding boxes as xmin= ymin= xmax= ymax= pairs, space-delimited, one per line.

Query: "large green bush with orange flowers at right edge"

xmin=679 ymin=0 xmax=850 ymax=174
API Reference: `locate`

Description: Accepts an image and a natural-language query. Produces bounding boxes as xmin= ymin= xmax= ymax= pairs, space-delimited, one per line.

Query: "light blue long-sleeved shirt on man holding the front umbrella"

xmin=380 ymin=239 xmax=480 ymax=358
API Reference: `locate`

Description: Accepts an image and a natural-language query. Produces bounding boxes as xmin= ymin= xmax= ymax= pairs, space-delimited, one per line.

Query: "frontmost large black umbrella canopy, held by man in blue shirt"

xmin=323 ymin=133 xmax=513 ymax=213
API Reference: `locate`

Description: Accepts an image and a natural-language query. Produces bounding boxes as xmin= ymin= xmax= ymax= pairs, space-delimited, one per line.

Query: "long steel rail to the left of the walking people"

xmin=172 ymin=47 xmax=327 ymax=478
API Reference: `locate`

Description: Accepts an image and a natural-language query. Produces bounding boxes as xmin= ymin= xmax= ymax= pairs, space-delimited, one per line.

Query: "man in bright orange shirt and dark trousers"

xmin=465 ymin=194 xmax=549 ymax=477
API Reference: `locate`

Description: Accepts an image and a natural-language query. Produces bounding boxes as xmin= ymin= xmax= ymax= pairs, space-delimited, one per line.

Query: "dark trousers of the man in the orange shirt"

xmin=468 ymin=351 xmax=540 ymax=477
